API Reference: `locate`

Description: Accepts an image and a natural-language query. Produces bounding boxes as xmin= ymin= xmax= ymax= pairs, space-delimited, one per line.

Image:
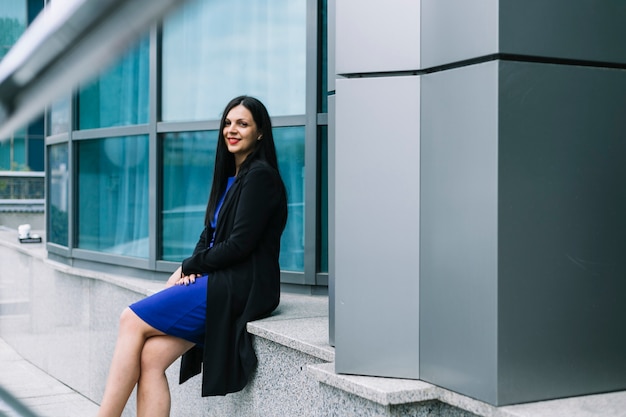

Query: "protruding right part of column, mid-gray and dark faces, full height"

xmin=420 ymin=0 xmax=626 ymax=405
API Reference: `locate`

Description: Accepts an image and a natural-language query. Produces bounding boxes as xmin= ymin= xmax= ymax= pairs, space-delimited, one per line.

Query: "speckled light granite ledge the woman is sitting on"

xmin=0 ymin=230 xmax=626 ymax=417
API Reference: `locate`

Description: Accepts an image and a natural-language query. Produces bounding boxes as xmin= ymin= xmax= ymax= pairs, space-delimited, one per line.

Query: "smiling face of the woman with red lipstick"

xmin=222 ymin=104 xmax=261 ymax=167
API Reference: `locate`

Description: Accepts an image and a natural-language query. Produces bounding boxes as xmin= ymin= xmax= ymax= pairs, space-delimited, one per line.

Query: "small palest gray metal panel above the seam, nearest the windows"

xmin=335 ymin=0 xmax=421 ymax=74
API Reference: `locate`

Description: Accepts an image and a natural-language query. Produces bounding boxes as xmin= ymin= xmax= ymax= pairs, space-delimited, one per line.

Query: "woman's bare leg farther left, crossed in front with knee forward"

xmin=98 ymin=308 xmax=163 ymax=417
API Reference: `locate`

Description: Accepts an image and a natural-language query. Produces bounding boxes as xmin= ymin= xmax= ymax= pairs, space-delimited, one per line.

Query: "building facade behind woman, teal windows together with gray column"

xmin=2 ymin=0 xmax=626 ymax=405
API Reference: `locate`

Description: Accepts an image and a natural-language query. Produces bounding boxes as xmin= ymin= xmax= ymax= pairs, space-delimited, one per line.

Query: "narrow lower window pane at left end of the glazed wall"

xmin=46 ymin=143 xmax=70 ymax=246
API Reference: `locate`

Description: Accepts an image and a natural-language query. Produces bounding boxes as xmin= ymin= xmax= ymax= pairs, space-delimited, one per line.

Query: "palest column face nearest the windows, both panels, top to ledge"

xmin=331 ymin=0 xmax=420 ymax=378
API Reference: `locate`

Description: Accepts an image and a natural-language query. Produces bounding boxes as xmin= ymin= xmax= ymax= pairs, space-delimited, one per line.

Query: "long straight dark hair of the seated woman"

xmin=204 ymin=96 xmax=278 ymax=226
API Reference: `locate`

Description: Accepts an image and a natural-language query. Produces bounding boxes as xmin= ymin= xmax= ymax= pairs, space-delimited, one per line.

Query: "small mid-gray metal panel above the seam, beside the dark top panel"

xmin=421 ymin=0 xmax=498 ymax=68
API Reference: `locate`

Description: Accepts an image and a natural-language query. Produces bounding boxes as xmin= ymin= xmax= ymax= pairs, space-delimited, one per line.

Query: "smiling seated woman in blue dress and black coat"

xmin=98 ymin=96 xmax=287 ymax=417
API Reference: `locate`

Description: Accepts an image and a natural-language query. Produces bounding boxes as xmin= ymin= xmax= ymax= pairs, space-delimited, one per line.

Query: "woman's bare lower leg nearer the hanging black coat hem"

xmin=137 ymin=336 xmax=194 ymax=417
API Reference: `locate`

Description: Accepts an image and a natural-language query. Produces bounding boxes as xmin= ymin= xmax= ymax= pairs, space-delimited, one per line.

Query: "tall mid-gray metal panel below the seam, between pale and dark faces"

xmin=420 ymin=62 xmax=498 ymax=402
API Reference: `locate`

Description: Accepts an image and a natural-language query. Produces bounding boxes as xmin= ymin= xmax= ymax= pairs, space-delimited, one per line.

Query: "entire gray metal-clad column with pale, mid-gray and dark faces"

xmin=333 ymin=0 xmax=626 ymax=405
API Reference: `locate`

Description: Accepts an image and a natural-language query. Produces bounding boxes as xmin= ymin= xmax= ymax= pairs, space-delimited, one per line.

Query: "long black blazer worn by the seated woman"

xmin=180 ymin=160 xmax=287 ymax=396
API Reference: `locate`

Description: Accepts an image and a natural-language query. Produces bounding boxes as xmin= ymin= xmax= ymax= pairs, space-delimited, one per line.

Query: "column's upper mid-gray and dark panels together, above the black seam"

xmin=421 ymin=0 xmax=626 ymax=68
